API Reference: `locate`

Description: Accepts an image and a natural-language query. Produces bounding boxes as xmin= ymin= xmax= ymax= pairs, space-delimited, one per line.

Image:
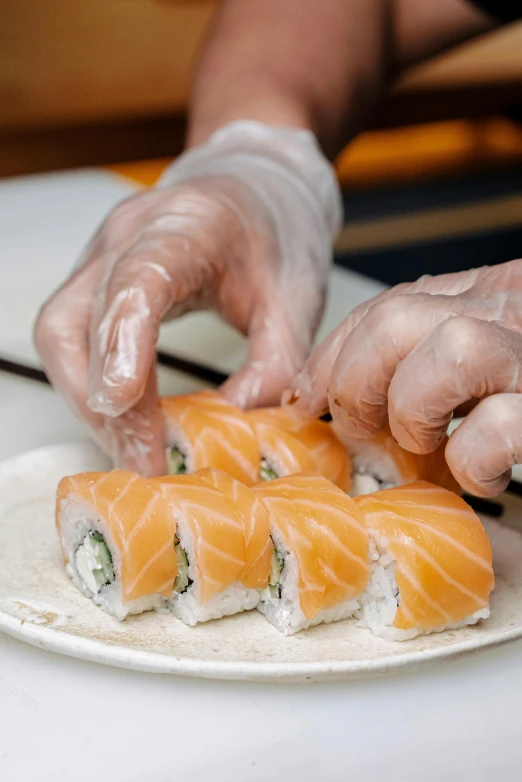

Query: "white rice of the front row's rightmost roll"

xmin=356 ymin=530 xmax=489 ymax=641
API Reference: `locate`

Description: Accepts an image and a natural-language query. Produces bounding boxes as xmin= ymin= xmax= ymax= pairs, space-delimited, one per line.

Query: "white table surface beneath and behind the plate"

xmin=0 ymin=172 xmax=522 ymax=782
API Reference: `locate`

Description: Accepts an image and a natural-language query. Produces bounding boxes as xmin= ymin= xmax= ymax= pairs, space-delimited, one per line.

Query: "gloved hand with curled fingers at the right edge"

xmin=283 ymin=260 xmax=522 ymax=496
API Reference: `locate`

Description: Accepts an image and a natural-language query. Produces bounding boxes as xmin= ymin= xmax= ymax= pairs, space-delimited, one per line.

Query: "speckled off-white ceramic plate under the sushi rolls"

xmin=0 ymin=445 xmax=522 ymax=681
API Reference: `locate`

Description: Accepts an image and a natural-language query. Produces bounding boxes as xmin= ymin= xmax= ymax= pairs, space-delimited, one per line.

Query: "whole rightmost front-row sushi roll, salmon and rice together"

xmin=355 ymin=481 xmax=494 ymax=641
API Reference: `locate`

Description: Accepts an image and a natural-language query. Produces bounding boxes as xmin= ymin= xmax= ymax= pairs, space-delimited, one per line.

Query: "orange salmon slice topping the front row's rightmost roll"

xmin=355 ymin=481 xmax=494 ymax=630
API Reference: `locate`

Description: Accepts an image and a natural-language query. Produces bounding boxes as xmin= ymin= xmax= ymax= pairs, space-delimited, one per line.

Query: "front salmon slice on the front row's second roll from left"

xmin=157 ymin=475 xmax=246 ymax=604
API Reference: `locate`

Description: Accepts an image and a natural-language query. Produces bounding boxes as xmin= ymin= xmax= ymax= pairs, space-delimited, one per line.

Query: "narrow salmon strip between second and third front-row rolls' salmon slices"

xmin=194 ymin=468 xmax=274 ymax=589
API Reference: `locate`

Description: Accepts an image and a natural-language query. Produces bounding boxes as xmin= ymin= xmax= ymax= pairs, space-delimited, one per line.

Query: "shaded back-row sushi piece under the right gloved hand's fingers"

xmin=338 ymin=424 xmax=456 ymax=497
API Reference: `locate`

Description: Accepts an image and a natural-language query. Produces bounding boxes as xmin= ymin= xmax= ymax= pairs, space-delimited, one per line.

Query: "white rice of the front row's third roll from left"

xmin=257 ymin=528 xmax=360 ymax=635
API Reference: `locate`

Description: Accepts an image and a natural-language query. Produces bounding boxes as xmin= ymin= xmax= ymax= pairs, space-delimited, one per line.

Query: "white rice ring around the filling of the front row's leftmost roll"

xmin=59 ymin=495 xmax=166 ymax=621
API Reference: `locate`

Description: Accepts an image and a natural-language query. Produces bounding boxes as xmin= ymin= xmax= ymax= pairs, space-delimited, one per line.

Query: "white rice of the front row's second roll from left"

xmin=169 ymin=519 xmax=260 ymax=626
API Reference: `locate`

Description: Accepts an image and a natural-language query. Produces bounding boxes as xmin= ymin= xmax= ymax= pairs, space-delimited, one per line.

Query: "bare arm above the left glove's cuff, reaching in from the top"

xmin=188 ymin=0 xmax=495 ymax=156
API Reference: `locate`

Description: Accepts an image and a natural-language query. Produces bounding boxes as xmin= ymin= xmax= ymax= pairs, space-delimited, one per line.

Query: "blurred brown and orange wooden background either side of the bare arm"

xmin=0 ymin=0 xmax=522 ymax=184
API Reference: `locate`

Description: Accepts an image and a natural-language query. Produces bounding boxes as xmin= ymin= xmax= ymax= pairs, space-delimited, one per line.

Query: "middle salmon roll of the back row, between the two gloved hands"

xmin=246 ymin=407 xmax=351 ymax=492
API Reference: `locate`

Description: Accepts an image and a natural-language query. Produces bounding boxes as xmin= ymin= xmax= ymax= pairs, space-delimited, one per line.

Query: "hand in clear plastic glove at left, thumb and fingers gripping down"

xmin=35 ymin=122 xmax=341 ymax=475
